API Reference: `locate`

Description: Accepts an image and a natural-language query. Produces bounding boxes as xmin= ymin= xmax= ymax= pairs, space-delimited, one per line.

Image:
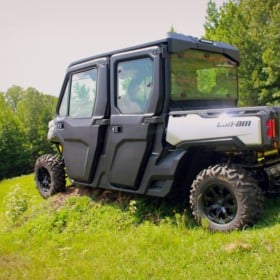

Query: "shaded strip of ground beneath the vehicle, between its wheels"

xmin=52 ymin=186 xmax=196 ymax=228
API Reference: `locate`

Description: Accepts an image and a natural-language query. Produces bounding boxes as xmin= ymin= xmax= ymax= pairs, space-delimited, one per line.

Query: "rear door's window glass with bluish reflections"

xmin=116 ymin=58 xmax=153 ymax=114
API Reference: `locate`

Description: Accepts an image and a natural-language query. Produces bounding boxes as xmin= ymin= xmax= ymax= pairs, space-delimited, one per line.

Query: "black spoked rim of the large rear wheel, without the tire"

xmin=202 ymin=184 xmax=237 ymax=224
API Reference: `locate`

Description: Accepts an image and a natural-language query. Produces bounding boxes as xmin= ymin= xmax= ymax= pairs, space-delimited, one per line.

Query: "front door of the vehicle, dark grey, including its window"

xmin=56 ymin=58 xmax=109 ymax=182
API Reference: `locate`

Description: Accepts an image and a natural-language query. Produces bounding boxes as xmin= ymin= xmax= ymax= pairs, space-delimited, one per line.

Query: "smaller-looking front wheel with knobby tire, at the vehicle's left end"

xmin=34 ymin=154 xmax=66 ymax=198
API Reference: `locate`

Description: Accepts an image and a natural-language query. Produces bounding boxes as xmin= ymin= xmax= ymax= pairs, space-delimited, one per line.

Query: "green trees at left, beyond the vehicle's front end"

xmin=0 ymin=86 xmax=57 ymax=179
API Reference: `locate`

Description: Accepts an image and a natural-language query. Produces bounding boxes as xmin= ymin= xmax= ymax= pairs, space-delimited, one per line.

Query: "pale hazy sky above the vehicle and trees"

xmin=0 ymin=0 xmax=225 ymax=96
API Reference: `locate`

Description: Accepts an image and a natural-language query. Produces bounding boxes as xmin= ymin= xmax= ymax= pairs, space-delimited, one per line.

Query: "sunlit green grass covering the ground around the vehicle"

xmin=0 ymin=175 xmax=280 ymax=280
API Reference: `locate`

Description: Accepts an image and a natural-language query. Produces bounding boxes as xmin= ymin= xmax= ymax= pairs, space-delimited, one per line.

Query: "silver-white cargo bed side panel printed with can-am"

xmin=166 ymin=114 xmax=262 ymax=145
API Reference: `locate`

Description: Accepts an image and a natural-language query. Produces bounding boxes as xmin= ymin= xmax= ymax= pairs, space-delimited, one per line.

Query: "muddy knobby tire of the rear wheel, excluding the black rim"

xmin=190 ymin=164 xmax=263 ymax=231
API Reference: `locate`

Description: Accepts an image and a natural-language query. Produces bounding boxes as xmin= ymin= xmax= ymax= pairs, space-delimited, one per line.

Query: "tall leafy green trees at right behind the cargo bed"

xmin=204 ymin=0 xmax=280 ymax=105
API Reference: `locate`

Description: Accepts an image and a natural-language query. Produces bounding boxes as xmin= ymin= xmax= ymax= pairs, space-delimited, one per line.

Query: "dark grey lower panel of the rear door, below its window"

xmin=107 ymin=117 xmax=154 ymax=188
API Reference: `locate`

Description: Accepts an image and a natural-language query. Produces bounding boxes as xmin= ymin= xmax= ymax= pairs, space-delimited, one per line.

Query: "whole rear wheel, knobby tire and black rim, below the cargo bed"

xmin=190 ymin=164 xmax=263 ymax=231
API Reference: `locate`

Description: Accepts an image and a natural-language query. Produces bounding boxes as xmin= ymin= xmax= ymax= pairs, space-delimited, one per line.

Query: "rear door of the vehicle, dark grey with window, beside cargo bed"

xmin=106 ymin=46 xmax=163 ymax=189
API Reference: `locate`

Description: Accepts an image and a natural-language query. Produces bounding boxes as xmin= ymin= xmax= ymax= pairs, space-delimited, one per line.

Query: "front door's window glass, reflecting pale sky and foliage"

xmin=69 ymin=68 xmax=97 ymax=118
